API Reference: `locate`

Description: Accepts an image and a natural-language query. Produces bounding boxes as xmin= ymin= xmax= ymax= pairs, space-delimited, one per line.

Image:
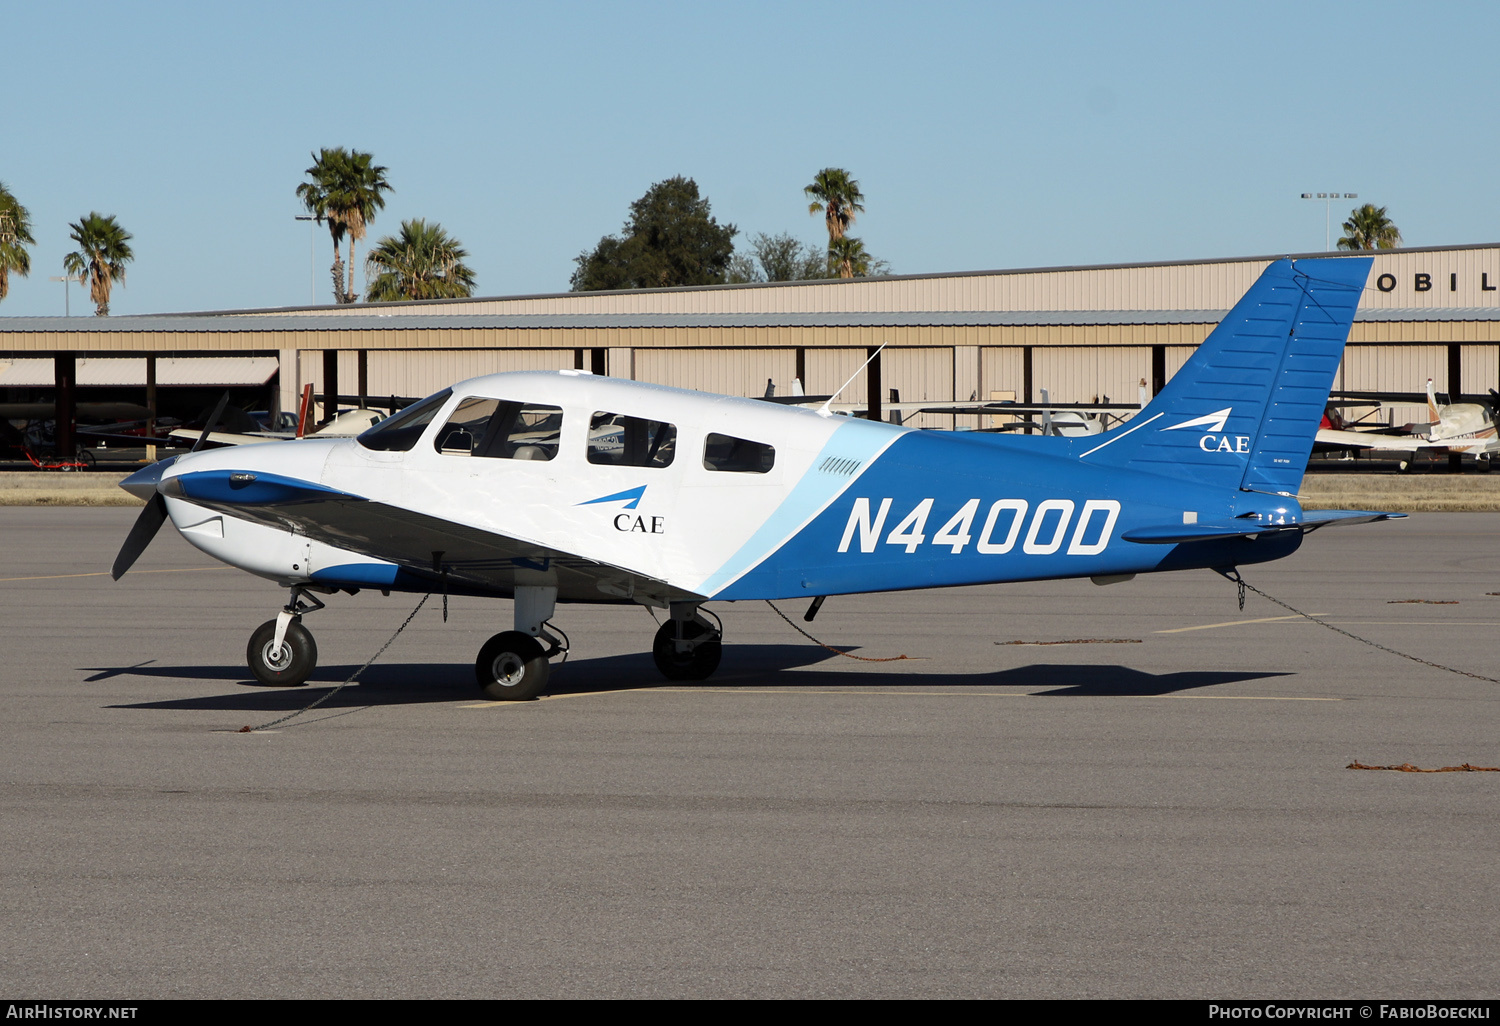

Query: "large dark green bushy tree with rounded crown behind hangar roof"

xmin=572 ymin=176 xmax=738 ymax=293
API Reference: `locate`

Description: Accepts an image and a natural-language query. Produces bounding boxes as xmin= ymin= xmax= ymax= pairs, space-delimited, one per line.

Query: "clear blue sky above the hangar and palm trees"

xmin=0 ymin=0 xmax=1500 ymax=315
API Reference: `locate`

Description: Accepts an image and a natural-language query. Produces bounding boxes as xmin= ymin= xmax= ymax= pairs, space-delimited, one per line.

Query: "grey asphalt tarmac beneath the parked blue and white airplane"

xmin=0 ymin=507 xmax=1500 ymax=1001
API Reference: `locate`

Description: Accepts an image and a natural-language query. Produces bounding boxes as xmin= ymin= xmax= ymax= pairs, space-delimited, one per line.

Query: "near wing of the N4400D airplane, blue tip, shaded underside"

xmin=162 ymin=470 xmax=705 ymax=606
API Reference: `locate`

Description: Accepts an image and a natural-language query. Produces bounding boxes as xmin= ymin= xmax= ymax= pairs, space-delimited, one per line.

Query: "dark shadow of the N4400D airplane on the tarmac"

xmin=84 ymin=645 xmax=1289 ymax=713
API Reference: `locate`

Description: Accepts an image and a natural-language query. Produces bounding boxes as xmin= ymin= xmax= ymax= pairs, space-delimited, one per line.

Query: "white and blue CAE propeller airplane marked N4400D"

xmin=113 ymin=257 xmax=1400 ymax=699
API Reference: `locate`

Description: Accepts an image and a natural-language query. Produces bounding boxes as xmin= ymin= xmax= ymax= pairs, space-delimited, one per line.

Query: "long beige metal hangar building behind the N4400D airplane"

xmin=0 ymin=243 xmax=1500 ymax=444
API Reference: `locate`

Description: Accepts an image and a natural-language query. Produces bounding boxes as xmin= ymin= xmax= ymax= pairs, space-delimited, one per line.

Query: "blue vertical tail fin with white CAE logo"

xmin=1076 ymin=257 xmax=1371 ymax=495
